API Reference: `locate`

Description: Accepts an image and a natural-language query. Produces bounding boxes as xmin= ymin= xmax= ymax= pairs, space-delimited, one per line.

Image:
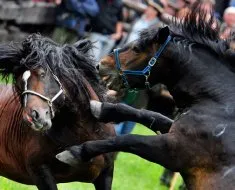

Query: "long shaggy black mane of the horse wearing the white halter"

xmin=0 ymin=34 xmax=105 ymax=109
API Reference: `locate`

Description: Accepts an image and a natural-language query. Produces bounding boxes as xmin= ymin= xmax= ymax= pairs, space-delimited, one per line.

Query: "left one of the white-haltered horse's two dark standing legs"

xmin=29 ymin=165 xmax=58 ymax=190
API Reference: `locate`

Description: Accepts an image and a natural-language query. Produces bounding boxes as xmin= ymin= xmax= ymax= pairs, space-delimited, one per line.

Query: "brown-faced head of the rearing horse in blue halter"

xmin=98 ymin=27 xmax=171 ymax=91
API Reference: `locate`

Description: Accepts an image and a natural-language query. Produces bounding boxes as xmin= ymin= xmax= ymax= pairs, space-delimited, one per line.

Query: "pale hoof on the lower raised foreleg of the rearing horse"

xmin=56 ymin=150 xmax=79 ymax=166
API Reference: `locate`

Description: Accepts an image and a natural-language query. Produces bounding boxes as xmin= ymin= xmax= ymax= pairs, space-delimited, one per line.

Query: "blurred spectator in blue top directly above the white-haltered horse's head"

xmin=53 ymin=0 xmax=99 ymax=44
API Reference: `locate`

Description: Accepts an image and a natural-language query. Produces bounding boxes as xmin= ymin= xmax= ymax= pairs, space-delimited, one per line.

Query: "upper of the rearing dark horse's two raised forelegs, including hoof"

xmin=90 ymin=100 xmax=173 ymax=133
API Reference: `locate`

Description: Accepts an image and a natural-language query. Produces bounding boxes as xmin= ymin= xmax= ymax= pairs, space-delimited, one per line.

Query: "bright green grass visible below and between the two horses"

xmin=0 ymin=125 xmax=181 ymax=190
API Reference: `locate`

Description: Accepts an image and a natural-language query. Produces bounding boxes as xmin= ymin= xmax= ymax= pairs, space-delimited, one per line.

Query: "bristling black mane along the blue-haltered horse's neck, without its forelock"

xmin=171 ymin=3 xmax=229 ymax=56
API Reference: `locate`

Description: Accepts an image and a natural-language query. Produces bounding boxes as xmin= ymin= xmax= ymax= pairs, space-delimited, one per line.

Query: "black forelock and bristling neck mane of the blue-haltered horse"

xmin=138 ymin=3 xmax=232 ymax=59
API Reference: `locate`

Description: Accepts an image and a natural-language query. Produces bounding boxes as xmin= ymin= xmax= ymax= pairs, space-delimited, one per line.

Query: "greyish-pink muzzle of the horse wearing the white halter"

xmin=23 ymin=108 xmax=52 ymax=131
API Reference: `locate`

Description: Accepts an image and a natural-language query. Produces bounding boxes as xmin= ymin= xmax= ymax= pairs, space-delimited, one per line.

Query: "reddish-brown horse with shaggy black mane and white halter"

xmin=0 ymin=34 xmax=115 ymax=190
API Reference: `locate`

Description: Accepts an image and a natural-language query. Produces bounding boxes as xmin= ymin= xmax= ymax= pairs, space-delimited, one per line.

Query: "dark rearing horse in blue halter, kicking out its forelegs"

xmin=57 ymin=5 xmax=235 ymax=190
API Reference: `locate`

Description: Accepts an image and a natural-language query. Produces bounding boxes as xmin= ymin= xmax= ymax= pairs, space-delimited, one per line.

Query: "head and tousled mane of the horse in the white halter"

xmin=0 ymin=34 xmax=99 ymax=132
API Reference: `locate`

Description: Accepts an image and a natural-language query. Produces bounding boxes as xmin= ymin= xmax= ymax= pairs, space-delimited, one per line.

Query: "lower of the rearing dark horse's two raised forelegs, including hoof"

xmin=56 ymin=133 xmax=181 ymax=170
